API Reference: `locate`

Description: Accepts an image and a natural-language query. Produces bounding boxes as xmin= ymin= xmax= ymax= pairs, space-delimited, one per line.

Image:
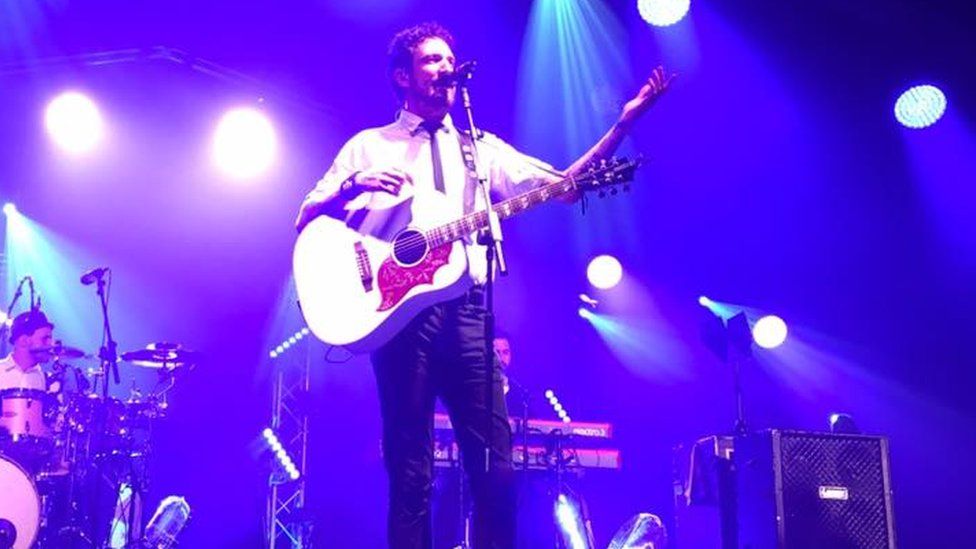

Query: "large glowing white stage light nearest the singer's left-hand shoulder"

xmin=213 ymin=108 xmax=278 ymax=179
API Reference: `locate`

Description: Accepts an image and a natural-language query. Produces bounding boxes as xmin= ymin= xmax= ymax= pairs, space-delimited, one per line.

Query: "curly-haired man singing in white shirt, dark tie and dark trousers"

xmin=296 ymin=23 xmax=670 ymax=548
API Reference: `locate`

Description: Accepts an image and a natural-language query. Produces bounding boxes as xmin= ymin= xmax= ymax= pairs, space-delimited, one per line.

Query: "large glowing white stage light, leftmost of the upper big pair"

xmin=44 ymin=92 xmax=105 ymax=154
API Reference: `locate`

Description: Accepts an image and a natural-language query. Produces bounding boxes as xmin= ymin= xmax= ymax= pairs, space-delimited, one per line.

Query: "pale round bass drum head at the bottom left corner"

xmin=0 ymin=456 xmax=41 ymax=549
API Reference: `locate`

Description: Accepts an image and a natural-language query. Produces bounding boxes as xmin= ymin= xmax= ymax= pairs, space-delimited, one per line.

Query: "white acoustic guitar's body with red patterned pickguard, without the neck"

xmin=293 ymin=212 xmax=471 ymax=353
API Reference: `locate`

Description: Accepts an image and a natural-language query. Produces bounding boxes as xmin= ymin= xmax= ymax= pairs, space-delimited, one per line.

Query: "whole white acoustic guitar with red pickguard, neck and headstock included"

xmin=294 ymin=159 xmax=639 ymax=353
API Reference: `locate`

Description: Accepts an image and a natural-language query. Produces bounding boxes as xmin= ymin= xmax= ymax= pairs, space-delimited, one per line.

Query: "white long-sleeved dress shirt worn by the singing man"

xmin=306 ymin=110 xmax=557 ymax=283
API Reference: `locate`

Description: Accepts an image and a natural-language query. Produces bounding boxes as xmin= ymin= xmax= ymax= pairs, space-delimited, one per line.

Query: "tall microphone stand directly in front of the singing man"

xmin=457 ymin=65 xmax=508 ymax=473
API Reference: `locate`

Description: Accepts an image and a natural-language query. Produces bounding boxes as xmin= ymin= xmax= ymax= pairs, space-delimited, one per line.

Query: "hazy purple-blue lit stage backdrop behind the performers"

xmin=0 ymin=0 xmax=976 ymax=547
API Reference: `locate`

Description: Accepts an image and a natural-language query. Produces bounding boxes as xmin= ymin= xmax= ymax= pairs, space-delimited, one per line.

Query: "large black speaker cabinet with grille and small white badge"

xmin=733 ymin=430 xmax=895 ymax=549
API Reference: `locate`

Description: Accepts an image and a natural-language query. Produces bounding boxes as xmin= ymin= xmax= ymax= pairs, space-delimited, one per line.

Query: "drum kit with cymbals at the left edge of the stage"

xmin=0 ymin=343 xmax=199 ymax=549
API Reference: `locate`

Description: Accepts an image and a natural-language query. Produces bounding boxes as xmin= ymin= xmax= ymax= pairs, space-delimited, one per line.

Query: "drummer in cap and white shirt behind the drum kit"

xmin=0 ymin=311 xmax=54 ymax=391
